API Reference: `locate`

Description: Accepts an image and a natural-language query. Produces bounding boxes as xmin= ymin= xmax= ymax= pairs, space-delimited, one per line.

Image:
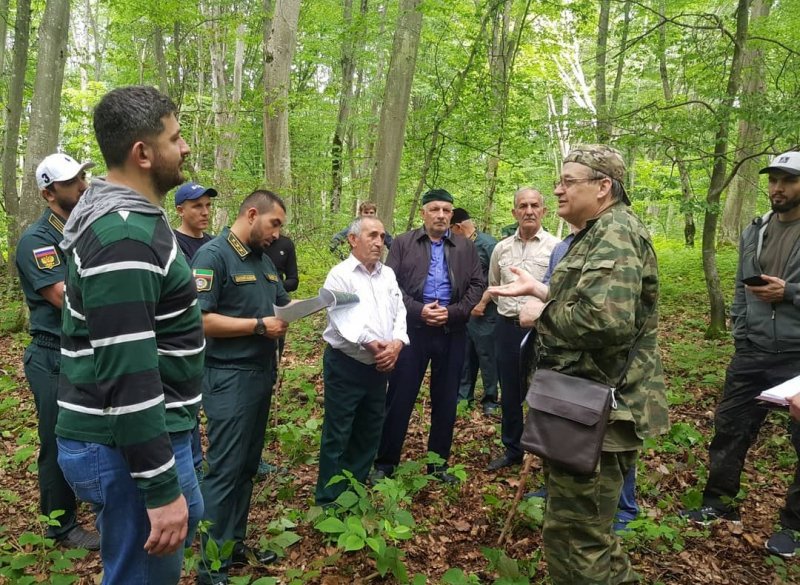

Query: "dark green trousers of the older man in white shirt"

xmin=315 ymin=346 xmax=389 ymax=505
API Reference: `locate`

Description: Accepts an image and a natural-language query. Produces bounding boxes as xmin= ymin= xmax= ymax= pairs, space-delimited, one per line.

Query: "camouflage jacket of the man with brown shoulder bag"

xmin=537 ymin=203 xmax=668 ymax=439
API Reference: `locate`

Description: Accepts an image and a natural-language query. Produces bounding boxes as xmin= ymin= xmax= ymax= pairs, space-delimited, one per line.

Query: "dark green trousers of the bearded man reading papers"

xmin=198 ymin=365 xmax=273 ymax=583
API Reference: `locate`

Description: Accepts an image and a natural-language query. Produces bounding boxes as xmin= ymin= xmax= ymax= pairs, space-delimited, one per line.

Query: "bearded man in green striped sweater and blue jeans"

xmin=56 ymin=86 xmax=205 ymax=584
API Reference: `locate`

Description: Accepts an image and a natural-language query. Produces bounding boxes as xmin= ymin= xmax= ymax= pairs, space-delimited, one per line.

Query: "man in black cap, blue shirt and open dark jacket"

xmin=374 ymin=189 xmax=486 ymax=483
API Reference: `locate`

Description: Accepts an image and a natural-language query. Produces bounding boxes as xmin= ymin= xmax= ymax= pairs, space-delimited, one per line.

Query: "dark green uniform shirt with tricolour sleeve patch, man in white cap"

xmin=16 ymin=209 xmax=66 ymax=337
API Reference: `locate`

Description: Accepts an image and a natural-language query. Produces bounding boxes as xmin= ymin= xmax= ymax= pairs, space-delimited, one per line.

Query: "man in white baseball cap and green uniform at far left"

xmin=16 ymin=153 xmax=100 ymax=550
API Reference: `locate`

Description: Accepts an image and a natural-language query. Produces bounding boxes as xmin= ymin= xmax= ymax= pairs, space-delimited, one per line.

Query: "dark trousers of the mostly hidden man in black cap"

xmin=458 ymin=303 xmax=497 ymax=404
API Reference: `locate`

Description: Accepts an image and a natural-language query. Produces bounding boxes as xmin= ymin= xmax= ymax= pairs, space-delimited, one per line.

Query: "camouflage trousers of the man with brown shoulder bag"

xmin=542 ymin=451 xmax=641 ymax=585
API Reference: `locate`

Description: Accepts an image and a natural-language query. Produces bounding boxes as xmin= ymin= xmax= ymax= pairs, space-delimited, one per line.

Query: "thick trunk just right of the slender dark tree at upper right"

xmin=720 ymin=0 xmax=772 ymax=244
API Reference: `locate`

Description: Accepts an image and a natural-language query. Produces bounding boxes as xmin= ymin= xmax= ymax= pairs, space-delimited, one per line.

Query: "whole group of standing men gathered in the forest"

xmin=17 ymin=80 xmax=800 ymax=584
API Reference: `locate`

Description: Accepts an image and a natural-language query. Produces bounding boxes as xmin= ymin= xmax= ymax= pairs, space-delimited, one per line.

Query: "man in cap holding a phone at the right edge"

xmin=682 ymin=152 xmax=800 ymax=557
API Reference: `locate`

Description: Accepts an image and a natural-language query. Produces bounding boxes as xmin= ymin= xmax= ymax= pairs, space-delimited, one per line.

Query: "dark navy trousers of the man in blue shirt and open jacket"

xmin=375 ymin=326 xmax=466 ymax=473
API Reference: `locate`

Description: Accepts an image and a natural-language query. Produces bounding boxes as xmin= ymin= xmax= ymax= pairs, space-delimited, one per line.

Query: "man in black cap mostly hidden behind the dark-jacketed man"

xmin=450 ymin=207 xmax=500 ymax=415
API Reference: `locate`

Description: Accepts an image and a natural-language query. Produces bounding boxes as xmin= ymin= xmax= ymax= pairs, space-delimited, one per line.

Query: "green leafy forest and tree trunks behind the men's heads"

xmin=0 ymin=0 xmax=800 ymax=328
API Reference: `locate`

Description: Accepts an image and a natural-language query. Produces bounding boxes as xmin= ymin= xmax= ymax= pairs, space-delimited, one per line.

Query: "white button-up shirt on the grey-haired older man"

xmin=322 ymin=254 xmax=409 ymax=364
